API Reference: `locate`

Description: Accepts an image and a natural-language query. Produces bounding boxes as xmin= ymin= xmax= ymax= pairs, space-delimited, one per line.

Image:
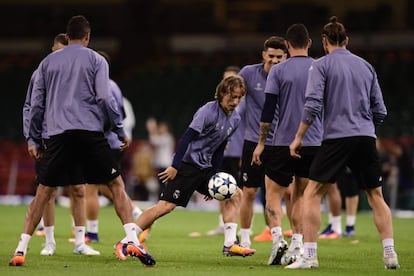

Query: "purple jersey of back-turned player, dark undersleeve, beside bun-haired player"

xmin=265 ymin=56 xmax=322 ymax=146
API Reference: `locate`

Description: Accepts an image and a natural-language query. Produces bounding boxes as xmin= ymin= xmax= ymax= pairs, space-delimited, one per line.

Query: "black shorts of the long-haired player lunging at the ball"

xmin=160 ymin=162 xmax=216 ymax=207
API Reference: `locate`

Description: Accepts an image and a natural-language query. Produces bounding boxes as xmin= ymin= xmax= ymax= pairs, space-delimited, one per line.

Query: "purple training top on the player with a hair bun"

xmin=302 ymin=49 xmax=387 ymax=140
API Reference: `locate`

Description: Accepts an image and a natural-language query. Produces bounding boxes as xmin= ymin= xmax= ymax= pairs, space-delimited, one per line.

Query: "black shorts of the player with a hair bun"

xmin=309 ymin=136 xmax=382 ymax=189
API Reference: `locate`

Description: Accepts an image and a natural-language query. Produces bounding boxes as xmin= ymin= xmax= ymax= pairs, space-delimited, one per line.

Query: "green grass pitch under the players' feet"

xmin=0 ymin=206 xmax=414 ymax=276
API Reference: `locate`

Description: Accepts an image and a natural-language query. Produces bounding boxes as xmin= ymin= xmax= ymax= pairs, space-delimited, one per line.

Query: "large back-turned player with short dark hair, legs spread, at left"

xmin=9 ymin=15 xmax=155 ymax=266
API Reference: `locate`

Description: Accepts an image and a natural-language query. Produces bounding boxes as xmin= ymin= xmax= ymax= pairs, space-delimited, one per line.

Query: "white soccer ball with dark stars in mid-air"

xmin=208 ymin=172 xmax=237 ymax=201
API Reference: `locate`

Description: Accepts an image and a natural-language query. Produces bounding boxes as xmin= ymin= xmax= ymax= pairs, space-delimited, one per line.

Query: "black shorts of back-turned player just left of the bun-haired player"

xmin=265 ymin=146 xmax=319 ymax=187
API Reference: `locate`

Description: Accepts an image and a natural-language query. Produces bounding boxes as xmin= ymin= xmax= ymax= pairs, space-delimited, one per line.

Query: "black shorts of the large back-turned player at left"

xmin=39 ymin=130 xmax=120 ymax=186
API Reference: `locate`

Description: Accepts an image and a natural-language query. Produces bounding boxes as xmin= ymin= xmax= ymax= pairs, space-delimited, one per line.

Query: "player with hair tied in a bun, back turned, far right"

xmin=286 ymin=16 xmax=399 ymax=269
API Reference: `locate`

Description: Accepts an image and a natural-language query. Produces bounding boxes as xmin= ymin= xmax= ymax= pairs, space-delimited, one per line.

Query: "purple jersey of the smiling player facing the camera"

xmin=239 ymin=63 xmax=277 ymax=145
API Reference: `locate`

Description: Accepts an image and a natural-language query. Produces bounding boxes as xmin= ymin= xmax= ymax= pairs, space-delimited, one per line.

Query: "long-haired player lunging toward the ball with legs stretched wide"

xmin=119 ymin=76 xmax=256 ymax=256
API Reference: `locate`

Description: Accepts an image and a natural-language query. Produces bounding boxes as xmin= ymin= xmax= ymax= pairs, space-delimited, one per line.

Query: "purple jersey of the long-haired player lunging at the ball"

xmin=182 ymin=101 xmax=241 ymax=169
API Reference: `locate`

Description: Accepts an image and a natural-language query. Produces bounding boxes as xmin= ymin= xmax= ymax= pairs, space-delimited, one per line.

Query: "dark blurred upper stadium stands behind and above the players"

xmin=0 ymin=0 xmax=414 ymax=141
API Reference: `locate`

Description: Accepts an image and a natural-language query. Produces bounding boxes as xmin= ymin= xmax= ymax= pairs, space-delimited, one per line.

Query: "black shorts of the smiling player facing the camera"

xmin=241 ymin=140 xmax=269 ymax=188
